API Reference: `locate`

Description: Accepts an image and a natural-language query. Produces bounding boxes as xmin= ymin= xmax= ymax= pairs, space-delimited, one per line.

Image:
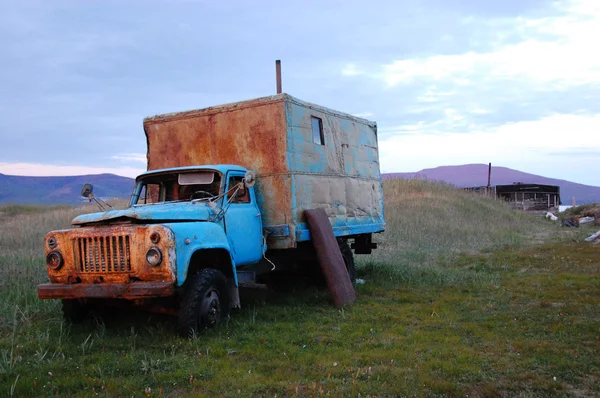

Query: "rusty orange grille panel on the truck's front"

xmin=40 ymin=224 xmax=176 ymax=284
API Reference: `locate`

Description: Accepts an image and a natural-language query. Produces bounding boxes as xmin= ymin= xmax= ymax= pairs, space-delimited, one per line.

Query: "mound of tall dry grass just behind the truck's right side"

xmin=358 ymin=179 xmax=557 ymax=285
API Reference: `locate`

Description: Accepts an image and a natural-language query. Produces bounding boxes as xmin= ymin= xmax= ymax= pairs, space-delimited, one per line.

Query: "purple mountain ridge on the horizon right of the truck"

xmin=383 ymin=164 xmax=600 ymax=204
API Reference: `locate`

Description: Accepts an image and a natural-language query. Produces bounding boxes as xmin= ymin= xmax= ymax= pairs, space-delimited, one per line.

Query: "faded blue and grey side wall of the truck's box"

xmin=286 ymin=99 xmax=385 ymax=241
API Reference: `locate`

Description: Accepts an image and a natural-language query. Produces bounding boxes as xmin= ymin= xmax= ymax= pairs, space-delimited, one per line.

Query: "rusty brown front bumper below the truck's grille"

xmin=38 ymin=282 xmax=175 ymax=300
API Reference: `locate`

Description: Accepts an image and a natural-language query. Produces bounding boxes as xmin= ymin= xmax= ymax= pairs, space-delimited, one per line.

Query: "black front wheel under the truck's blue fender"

xmin=177 ymin=268 xmax=229 ymax=337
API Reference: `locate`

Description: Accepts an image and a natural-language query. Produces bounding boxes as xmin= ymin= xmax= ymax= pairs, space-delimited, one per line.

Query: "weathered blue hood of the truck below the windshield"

xmin=72 ymin=202 xmax=215 ymax=225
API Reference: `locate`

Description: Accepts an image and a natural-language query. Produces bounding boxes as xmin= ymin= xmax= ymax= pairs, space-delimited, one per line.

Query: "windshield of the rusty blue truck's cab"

xmin=130 ymin=170 xmax=221 ymax=206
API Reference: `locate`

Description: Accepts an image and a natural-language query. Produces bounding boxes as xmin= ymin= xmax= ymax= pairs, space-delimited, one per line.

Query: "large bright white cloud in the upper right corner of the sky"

xmin=380 ymin=0 xmax=600 ymax=90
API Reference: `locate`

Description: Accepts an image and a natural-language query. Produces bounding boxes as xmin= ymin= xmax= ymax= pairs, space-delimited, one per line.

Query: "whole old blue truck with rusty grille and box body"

xmin=38 ymin=94 xmax=385 ymax=335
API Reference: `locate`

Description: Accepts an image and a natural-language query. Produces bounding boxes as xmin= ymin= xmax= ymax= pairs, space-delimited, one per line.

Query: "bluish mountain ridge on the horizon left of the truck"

xmin=0 ymin=174 xmax=135 ymax=204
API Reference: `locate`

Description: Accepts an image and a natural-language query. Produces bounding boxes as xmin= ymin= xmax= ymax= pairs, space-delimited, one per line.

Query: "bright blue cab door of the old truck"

xmin=224 ymin=171 xmax=264 ymax=266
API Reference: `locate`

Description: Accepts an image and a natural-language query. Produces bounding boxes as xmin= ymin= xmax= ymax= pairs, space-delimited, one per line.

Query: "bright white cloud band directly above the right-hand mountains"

xmin=379 ymin=114 xmax=600 ymax=186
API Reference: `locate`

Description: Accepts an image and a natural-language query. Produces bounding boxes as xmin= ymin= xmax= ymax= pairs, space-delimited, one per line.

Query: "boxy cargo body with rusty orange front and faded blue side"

xmin=144 ymin=94 xmax=385 ymax=249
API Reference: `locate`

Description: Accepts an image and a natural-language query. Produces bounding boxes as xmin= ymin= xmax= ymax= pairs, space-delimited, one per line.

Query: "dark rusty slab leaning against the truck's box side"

xmin=304 ymin=209 xmax=356 ymax=307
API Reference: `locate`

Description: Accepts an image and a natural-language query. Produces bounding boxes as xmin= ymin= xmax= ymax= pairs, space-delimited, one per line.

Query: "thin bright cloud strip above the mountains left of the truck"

xmin=0 ymin=163 xmax=146 ymax=178
